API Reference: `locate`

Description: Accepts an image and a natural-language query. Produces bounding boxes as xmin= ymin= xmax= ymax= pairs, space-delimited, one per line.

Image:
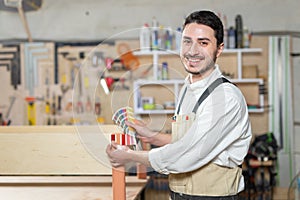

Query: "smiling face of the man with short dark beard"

xmin=180 ymin=23 xmax=223 ymax=78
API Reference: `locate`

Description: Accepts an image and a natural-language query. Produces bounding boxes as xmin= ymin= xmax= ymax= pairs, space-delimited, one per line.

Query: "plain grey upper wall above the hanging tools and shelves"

xmin=0 ymin=0 xmax=300 ymax=40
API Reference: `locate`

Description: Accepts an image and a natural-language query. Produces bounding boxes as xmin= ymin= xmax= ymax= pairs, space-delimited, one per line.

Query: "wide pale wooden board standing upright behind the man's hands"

xmin=0 ymin=125 xmax=119 ymax=175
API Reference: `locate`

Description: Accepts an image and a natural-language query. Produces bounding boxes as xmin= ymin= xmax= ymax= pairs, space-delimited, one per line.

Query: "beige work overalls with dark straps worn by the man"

xmin=169 ymin=78 xmax=242 ymax=196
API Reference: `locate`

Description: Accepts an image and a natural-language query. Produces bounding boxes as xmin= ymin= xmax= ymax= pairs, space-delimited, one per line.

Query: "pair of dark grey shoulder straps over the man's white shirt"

xmin=176 ymin=77 xmax=231 ymax=115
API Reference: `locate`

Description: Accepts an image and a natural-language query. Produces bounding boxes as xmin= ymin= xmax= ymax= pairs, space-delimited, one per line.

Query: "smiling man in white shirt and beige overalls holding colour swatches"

xmin=106 ymin=11 xmax=251 ymax=199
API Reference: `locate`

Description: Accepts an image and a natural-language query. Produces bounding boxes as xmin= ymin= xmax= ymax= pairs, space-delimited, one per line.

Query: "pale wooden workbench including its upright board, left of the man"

xmin=0 ymin=125 xmax=147 ymax=200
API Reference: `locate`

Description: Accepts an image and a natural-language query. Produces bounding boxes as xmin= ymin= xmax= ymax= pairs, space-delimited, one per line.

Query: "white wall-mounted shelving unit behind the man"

xmin=133 ymin=48 xmax=264 ymax=115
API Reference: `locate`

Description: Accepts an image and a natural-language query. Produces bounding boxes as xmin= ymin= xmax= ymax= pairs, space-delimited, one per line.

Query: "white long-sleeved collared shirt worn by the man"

xmin=149 ymin=65 xmax=252 ymax=191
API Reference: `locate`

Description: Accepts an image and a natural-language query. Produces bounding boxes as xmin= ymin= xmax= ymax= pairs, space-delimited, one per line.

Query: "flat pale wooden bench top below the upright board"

xmin=0 ymin=176 xmax=147 ymax=200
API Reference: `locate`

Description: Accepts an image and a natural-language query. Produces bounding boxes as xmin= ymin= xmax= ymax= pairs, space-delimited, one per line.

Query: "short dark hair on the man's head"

xmin=183 ymin=10 xmax=224 ymax=46
